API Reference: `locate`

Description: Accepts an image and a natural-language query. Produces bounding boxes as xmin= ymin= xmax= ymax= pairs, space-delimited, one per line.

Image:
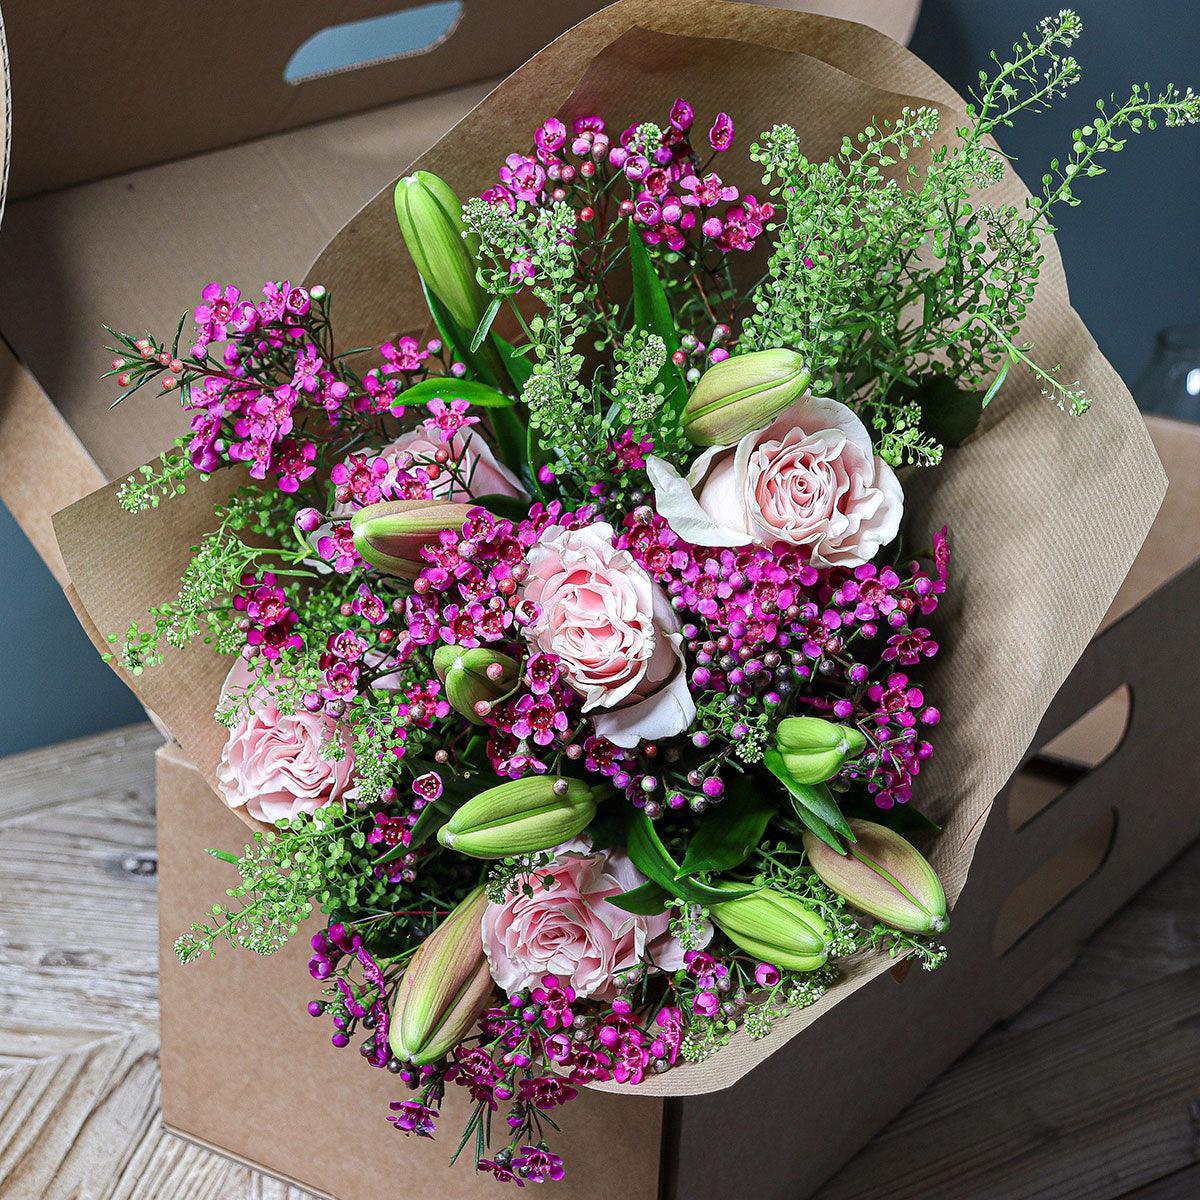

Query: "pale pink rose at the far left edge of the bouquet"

xmin=217 ymin=659 xmax=354 ymax=824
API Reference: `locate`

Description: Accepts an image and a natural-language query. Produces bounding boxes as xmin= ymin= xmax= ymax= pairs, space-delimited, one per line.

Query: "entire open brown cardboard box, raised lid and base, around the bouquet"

xmin=0 ymin=0 xmax=1200 ymax=1200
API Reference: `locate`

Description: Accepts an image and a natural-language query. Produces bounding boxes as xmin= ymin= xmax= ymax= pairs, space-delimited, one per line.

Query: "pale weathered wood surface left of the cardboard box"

xmin=0 ymin=725 xmax=312 ymax=1200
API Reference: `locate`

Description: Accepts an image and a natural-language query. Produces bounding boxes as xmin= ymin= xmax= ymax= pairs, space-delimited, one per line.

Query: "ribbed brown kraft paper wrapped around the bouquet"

xmin=55 ymin=0 xmax=1165 ymax=1096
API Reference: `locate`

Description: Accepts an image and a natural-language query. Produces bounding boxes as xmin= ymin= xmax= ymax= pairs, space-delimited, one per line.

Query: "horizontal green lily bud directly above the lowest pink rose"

xmin=438 ymin=775 xmax=596 ymax=858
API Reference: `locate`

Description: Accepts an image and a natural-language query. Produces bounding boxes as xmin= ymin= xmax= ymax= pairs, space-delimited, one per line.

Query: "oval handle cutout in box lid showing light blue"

xmin=283 ymin=0 xmax=462 ymax=84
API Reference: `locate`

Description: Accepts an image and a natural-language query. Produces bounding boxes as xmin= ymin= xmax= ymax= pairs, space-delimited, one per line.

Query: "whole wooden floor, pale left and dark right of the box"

xmin=0 ymin=726 xmax=1200 ymax=1200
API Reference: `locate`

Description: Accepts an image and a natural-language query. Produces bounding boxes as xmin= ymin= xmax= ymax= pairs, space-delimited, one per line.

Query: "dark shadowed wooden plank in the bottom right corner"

xmin=818 ymin=967 xmax=1200 ymax=1200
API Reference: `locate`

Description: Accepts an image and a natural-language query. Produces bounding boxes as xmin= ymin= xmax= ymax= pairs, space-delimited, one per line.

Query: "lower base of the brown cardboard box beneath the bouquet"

xmin=158 ymin=418 xmax=1200 ymax=1200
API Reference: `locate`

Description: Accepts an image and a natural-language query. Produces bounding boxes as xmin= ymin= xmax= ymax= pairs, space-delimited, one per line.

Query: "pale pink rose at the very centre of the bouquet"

xmin=524 ymin=522 xmax=696 ymax=746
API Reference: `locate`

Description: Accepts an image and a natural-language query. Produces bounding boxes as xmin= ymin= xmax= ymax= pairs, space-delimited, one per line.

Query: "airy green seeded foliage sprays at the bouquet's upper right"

xmin=740 ymin=10 xmax=1200 ymax=464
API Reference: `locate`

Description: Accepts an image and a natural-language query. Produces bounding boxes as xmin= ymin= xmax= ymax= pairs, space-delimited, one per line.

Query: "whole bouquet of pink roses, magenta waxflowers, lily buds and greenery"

xmin=51 ymin=6 xmax=1200 ymax=1184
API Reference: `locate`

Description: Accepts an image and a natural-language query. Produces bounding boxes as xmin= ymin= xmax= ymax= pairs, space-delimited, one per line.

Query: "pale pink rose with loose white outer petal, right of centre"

xmin=647 ymin=396 xmax=904 ymax=566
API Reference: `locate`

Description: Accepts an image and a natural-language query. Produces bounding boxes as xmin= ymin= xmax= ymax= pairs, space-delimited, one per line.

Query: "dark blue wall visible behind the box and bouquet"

xmin=0 ymin=0 xmax=1200 ymax=754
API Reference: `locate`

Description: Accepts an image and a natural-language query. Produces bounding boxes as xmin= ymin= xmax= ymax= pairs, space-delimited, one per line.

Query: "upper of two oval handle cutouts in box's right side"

xmin=1008 ymin=684 xmax=1133 ymax=829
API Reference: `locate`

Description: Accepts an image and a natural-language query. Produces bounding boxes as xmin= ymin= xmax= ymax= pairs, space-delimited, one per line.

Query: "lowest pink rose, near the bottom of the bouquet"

xmin=481 ymin=839 xmax=713 ymax=1000
